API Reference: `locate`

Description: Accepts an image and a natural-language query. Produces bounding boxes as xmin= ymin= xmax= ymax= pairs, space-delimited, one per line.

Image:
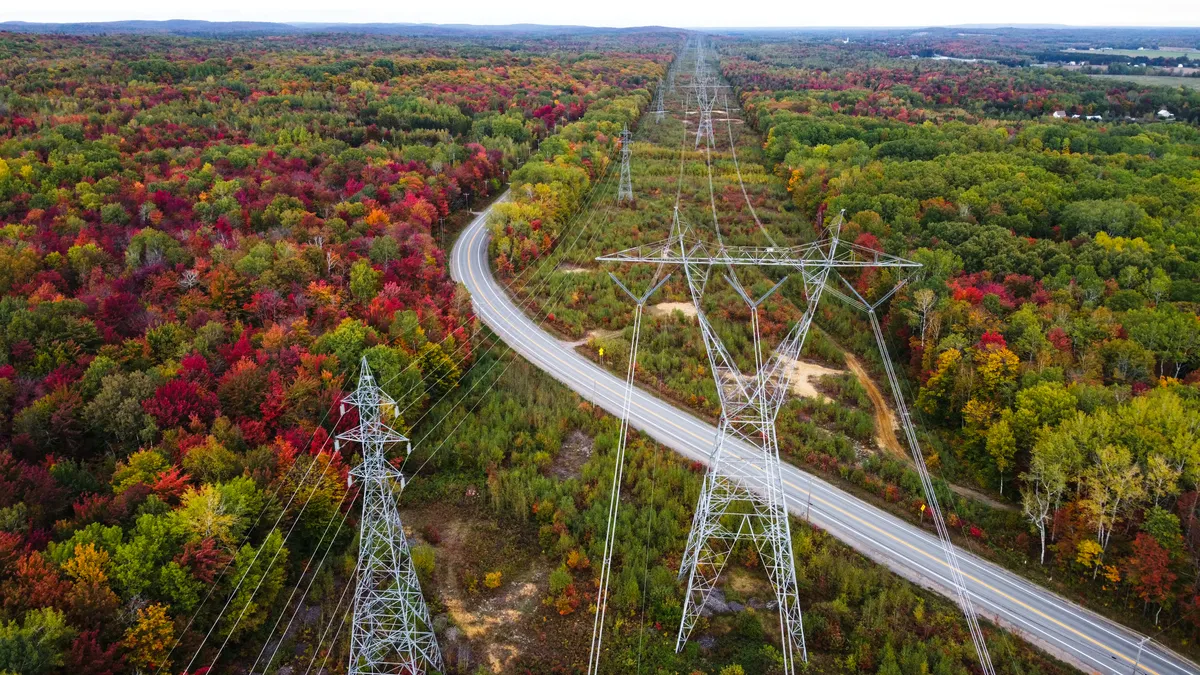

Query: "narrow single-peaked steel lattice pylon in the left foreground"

xmin=337 ymin=358 xmax=442 ymax=675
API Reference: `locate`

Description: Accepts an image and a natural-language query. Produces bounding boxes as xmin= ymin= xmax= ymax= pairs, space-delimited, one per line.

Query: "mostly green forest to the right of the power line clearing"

xmin=727 ymin=34 xmax=1200 ymax=641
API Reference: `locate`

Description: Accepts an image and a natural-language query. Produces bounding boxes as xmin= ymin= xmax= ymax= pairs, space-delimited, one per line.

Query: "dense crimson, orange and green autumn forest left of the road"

xmin=0 ymin=28 xmax=676 ymax=674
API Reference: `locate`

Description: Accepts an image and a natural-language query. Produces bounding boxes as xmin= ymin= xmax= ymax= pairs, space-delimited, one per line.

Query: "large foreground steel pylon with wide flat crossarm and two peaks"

xmin=598 ymin=207 xmax=992 ymax=674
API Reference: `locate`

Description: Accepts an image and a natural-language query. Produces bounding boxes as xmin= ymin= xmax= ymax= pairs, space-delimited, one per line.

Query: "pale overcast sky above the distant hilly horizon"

xmin=7 ymin=0 xmax=1200 ymax=28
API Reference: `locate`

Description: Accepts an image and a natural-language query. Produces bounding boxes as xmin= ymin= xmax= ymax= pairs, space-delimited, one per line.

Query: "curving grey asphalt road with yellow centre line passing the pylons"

xmin=450 ymin=195 xmax=1200 ymax=675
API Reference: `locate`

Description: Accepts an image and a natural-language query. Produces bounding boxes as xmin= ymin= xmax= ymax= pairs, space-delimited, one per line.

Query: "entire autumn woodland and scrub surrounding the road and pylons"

xmin=0 ymin=25 xmax=1200 ymax=675
